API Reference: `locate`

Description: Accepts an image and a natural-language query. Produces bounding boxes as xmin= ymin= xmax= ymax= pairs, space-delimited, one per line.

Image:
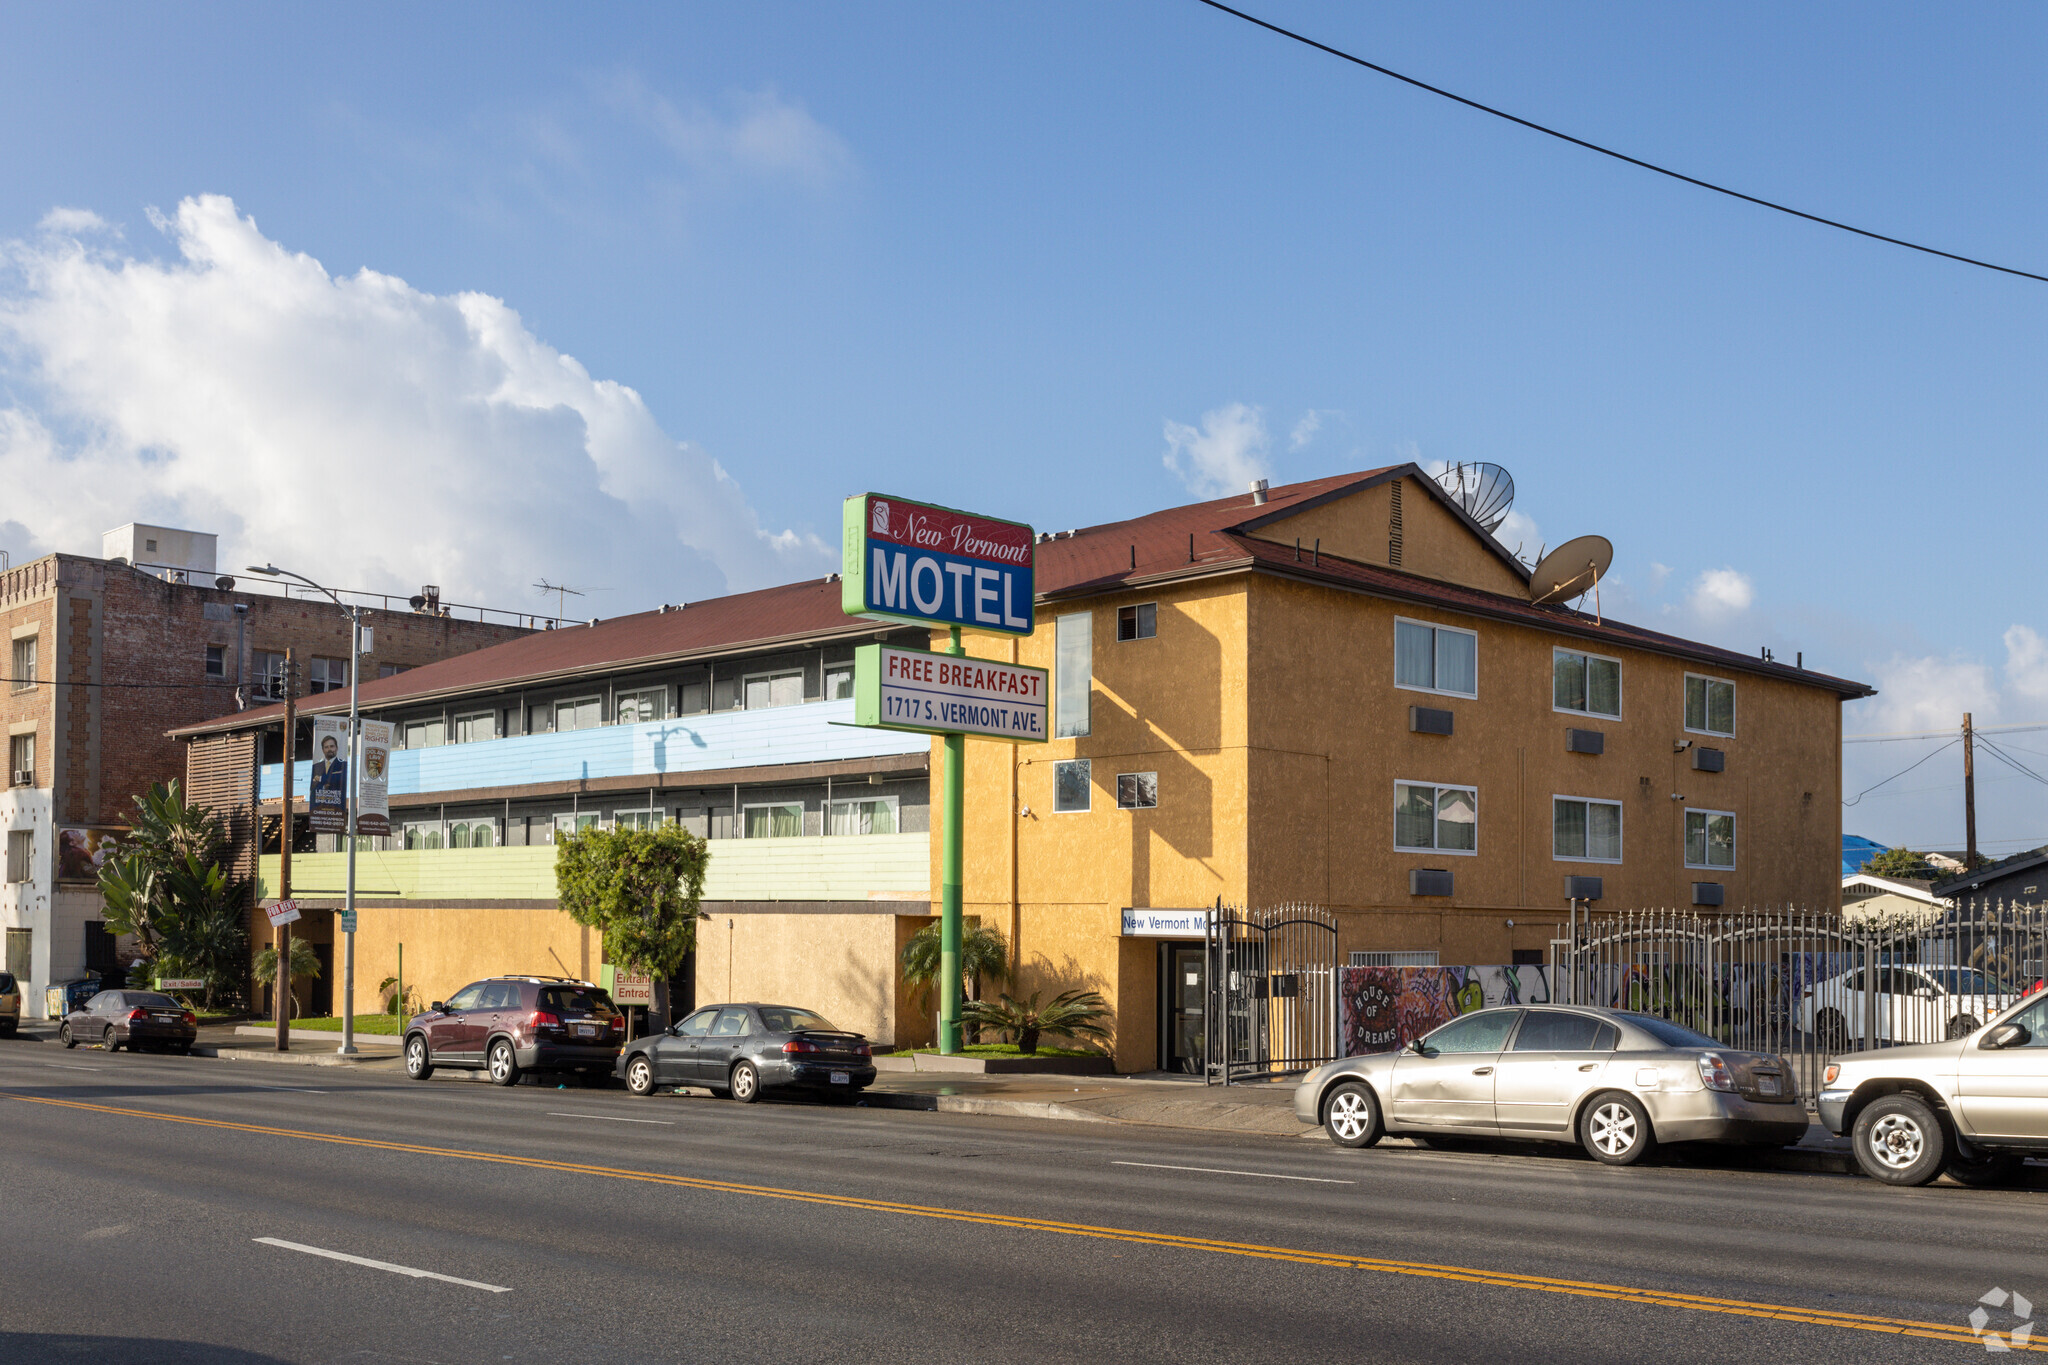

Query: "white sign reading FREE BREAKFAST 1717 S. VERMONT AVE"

xmin=854 ymin=645 xmax=1053 ymax=745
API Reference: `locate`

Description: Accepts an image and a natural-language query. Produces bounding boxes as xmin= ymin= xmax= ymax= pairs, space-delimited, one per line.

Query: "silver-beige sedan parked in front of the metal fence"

xmin=1294 ymin=1005 xmax=1806 ymax=1166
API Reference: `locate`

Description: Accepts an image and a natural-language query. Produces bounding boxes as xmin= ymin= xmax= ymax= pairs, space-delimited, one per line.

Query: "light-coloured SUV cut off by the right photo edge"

xmin=1821 ymin=995 xmax=2048 ymax=1185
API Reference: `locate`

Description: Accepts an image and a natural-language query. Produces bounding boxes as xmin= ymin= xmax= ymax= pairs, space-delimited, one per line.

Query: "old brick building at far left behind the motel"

xmin=0 ymin=526 xmax=530 ymax=1017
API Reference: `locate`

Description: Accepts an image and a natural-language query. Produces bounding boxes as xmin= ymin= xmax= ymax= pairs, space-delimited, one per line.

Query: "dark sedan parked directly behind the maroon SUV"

xmin=614 ymin=1005 xmax=874 ymax=1105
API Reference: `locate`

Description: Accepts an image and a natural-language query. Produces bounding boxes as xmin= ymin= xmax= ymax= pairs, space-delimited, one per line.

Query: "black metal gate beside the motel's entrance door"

xmin=1202 ymin=900 xmax=1337 ymax=1085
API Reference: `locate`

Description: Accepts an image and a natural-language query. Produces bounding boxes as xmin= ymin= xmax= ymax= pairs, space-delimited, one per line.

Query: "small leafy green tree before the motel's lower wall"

xmin=555 ymin=825 xmax=711 ymax=998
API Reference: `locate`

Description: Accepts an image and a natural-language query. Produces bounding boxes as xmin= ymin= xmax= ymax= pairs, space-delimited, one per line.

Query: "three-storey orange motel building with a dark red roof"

xmin=178 ymin=465 xmax=1870 ymax=1070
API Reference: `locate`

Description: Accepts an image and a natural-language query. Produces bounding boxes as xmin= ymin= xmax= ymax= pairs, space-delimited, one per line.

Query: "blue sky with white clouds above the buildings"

xmin=0 ymin=0 xmax=2048 ymax=851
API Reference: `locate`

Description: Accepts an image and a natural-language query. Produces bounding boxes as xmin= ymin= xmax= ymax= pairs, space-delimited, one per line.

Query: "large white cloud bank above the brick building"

xmin=0 ymin=196 xmax=834 ymax=614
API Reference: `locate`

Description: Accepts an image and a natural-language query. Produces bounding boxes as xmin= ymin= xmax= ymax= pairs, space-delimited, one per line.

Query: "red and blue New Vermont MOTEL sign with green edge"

xmin=840 ymin=493 xmax=1032 ymax=634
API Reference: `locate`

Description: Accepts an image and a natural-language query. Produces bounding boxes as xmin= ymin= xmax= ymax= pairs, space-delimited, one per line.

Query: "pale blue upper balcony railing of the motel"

xmin=262 ymin=700 xmax=930 ymax=800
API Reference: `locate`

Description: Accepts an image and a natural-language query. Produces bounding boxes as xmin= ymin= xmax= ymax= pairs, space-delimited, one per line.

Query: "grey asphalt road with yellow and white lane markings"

xmin=0 ymin=1040 xmax=2048 ymax=1365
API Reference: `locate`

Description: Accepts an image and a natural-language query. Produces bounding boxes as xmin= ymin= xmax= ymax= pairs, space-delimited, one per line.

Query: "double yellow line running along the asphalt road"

xmin=0 ymin=1091 xmax=2048 ymax=1353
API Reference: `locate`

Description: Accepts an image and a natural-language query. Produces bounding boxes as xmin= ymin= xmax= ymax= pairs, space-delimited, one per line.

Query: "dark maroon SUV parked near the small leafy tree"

xmin=403 ymin=976 xmax=627 ymax=1085
